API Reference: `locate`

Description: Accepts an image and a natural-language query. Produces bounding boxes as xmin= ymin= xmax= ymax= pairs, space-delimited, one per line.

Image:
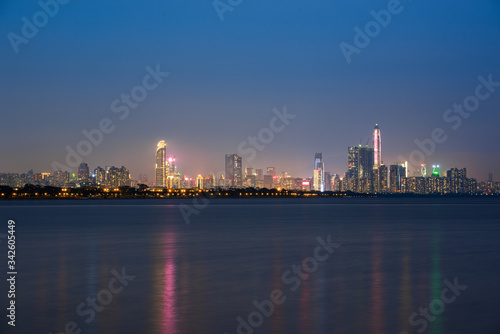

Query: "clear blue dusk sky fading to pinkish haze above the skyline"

xmin=0 ymin=0 xmax=500 ymax=180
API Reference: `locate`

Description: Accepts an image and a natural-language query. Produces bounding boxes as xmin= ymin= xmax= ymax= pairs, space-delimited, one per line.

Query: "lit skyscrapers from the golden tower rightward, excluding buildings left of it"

xmin=155 ymin=124 xmax=490 ymax=195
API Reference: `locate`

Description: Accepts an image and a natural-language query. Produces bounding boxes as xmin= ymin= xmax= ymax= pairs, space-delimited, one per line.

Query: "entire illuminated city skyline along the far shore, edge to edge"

xmin=0 ymin=125 xmax=500 ymax=195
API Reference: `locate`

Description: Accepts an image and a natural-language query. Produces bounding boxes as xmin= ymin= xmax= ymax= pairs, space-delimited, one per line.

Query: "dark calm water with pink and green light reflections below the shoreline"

xmin=0 ymin=199 xmax=500 ymax=334
